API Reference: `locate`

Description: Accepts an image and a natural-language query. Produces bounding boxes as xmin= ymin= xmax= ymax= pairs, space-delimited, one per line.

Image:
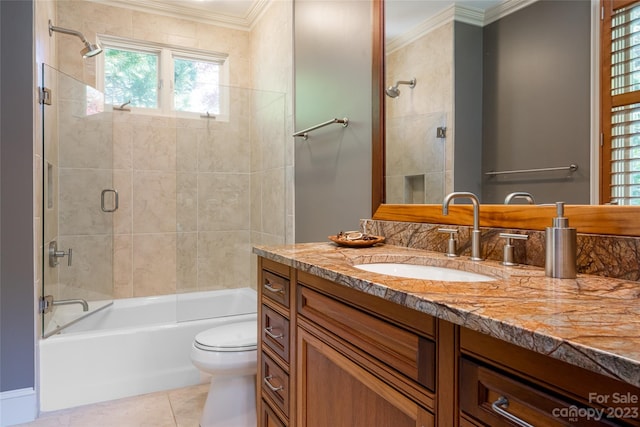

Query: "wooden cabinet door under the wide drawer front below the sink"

xmin=297 ymin=328 xmax=434 ymax=427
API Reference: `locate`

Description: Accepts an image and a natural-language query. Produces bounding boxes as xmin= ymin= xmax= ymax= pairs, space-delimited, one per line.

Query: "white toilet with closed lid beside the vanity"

xmin=191 ymin=319 xmax=258 ymax=427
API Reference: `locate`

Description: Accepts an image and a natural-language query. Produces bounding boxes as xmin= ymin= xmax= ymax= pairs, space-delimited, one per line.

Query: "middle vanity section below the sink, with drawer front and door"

xmin=296 ymin=272 xmax=435 ymax=427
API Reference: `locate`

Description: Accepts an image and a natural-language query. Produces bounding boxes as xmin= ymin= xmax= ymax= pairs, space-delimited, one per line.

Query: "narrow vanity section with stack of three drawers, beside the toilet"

xmin=256 ymin=257 xmax=295 ymax=427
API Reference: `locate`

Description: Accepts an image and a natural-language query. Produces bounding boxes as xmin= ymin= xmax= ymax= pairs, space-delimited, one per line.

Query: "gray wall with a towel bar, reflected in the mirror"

xmin=480 ymin=0 xmax=591 ymax=203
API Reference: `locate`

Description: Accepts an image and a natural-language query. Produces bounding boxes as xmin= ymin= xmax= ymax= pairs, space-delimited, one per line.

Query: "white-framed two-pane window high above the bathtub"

xmin=98 ymin=36 xmax=228 ymax=119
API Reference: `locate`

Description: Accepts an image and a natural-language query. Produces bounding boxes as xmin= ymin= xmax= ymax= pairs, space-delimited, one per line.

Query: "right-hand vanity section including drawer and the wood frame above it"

xmin=459 ymin=328 xmax=640 ymax=427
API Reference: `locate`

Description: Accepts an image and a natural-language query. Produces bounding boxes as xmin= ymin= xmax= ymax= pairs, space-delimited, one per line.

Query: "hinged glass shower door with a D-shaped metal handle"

xmin=41 ymin=65 xmax=119 ymax=337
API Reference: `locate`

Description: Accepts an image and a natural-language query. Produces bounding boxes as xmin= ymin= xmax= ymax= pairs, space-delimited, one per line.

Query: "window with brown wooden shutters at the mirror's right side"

xmin=600 ymin=0 xmax=640 ymax=206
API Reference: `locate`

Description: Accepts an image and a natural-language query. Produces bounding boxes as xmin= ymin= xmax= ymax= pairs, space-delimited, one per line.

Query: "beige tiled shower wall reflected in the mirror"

xmin=385 ymin=22 xmax=454 ymax=204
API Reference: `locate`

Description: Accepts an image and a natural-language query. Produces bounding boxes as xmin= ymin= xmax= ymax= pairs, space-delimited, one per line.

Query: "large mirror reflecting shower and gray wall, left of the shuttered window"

xmin=374 ymin=0 xmax=595 ymax=207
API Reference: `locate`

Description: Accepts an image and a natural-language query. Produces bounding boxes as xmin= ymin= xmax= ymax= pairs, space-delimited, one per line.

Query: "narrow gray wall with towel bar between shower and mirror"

xmin=294 ymin=0 xmax=372 ymax=242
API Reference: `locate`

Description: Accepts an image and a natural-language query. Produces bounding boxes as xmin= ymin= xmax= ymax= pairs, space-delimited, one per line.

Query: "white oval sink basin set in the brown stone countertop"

xmin=354 ymin=263 xmax=496 ymax=282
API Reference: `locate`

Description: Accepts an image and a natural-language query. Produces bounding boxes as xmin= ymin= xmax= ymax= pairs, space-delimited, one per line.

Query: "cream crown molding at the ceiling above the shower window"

xmin=90 ymin=0 xmax=271 ymax=31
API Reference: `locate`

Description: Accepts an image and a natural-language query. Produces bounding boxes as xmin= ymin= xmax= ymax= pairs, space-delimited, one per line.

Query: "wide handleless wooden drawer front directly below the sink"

xmin=298 ymin=286 xmax=435 ymax=391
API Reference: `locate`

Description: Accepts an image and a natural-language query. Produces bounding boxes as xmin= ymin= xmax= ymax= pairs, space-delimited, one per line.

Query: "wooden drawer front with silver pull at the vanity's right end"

xmin=460 ymin=358 xmax=619 ymax=427
